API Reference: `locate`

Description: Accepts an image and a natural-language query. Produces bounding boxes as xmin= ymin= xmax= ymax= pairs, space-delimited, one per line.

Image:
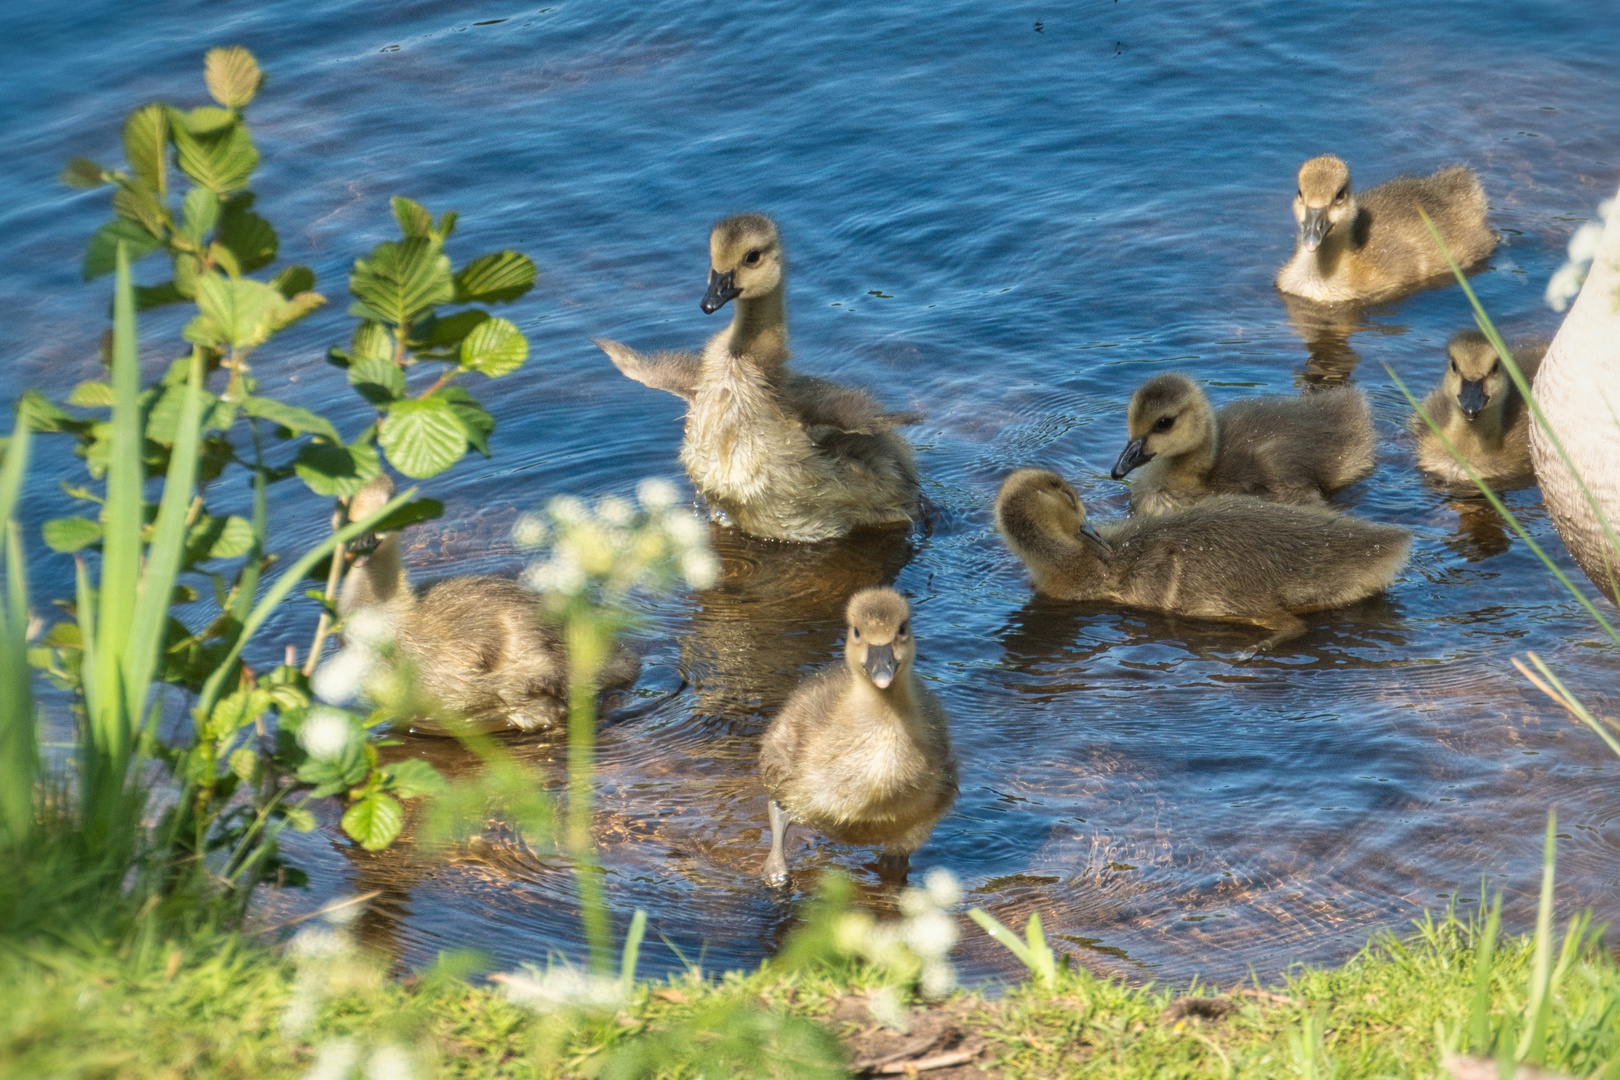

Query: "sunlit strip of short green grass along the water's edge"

xmin=0 ymin=915 xmax=1620 ymax=1078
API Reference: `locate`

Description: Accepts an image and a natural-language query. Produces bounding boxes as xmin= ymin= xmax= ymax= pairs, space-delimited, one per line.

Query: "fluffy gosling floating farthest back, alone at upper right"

xmin=1277 ymin=154 xmax=1497 ymax=303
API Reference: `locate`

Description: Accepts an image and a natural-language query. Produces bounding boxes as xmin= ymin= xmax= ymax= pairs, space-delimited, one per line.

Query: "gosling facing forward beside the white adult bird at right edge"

xmin=1411 ymin=330 xmax=1547 ymax=489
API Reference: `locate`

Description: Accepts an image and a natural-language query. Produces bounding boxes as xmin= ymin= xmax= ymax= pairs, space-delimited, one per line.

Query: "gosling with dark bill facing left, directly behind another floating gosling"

xmin=1113 ymin=372 xmax=1377 ymax=515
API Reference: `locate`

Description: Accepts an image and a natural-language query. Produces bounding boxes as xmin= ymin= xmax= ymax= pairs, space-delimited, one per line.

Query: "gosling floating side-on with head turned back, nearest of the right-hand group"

xmin=996 ymin=470 xmax=1411 ymax=657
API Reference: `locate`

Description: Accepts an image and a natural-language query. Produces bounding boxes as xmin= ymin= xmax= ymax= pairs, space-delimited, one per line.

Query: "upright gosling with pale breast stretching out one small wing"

xmin=596 ymin=214 xmax=922 ymax=542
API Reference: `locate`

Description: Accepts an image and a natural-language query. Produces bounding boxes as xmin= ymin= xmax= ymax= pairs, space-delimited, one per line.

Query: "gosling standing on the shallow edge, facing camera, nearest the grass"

xmin=760 ymin=589 xmax=956 ymax=884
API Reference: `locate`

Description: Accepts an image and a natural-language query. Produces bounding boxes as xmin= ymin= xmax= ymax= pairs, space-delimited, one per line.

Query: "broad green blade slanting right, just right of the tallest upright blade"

xmin=123 ymin=347 xmax=206 ymax=735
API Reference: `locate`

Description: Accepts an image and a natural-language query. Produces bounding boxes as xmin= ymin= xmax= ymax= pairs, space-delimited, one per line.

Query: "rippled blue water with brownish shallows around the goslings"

xmin=0 ymin=0 xmax=1620 ymax=980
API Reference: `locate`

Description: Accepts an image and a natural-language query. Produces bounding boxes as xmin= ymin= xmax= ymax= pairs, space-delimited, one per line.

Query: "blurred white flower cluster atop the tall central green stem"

xmin=512 ymin=478 xmax=719 ymax=609
